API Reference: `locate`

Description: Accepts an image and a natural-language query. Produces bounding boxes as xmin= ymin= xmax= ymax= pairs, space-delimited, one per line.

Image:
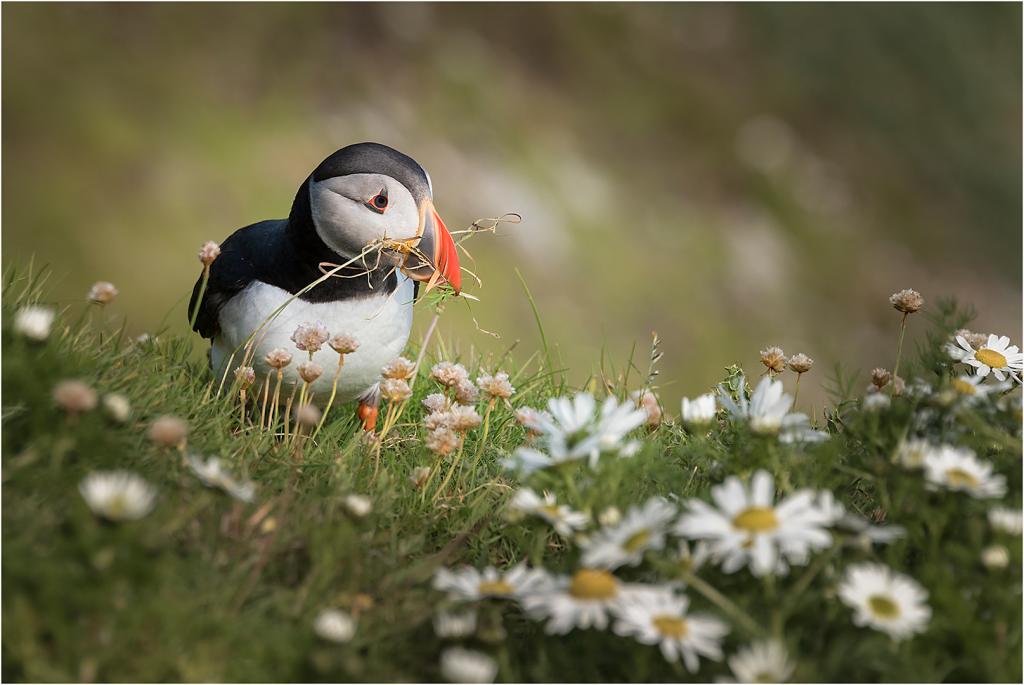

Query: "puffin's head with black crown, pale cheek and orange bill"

xmin=289 ymin=142 xmax=462 ymax=291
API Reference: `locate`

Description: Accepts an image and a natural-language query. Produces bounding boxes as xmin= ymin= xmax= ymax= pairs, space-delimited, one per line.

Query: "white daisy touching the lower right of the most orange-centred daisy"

xmin=612 ymin=590 xmax=729 ymax=673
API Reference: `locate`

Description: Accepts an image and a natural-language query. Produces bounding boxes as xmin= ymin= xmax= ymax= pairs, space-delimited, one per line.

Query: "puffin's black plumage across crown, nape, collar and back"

xmin=187 ymin=142 xmax=430 ymax=338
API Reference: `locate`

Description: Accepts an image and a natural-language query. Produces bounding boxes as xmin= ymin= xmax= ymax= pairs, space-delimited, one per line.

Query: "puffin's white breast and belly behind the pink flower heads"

xmin=210 ymin=273 xmax=414 ymax=404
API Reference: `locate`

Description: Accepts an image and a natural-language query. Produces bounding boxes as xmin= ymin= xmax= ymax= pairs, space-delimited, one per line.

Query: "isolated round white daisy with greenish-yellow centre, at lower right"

xmin=839 ymin=562 xmax=932 ymax=640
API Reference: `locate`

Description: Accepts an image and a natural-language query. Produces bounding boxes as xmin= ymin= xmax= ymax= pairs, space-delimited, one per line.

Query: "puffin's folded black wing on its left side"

xmin=188 ymin=219 xmax=288 ymax=338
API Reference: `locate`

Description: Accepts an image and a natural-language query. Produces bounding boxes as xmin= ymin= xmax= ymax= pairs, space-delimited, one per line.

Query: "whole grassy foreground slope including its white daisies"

xmin=0 ymin=264 xmax=1021 ymax=681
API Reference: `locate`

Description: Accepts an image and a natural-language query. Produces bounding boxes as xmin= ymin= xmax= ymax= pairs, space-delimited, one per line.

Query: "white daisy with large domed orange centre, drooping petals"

xmin=519 ymin=568 xmax=632 ymax=635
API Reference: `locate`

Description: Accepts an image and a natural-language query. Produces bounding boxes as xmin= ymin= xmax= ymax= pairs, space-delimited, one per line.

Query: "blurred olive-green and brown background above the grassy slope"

xmin=2 ymin=3 xmax=1022 ymax=405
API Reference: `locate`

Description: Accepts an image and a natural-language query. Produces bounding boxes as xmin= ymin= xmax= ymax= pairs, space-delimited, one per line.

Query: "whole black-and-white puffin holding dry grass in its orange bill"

xmin=188 ymin=142 xmax=462 ymax=431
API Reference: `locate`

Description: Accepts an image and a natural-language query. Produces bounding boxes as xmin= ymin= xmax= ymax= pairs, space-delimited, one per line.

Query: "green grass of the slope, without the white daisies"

xmin=2 ymin=272 xmax=1021 ymax=682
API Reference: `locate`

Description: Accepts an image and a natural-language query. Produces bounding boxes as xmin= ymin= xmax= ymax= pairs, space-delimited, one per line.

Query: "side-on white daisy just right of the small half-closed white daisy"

xmin=718 ymin=376 xmax=828 ymax=442
